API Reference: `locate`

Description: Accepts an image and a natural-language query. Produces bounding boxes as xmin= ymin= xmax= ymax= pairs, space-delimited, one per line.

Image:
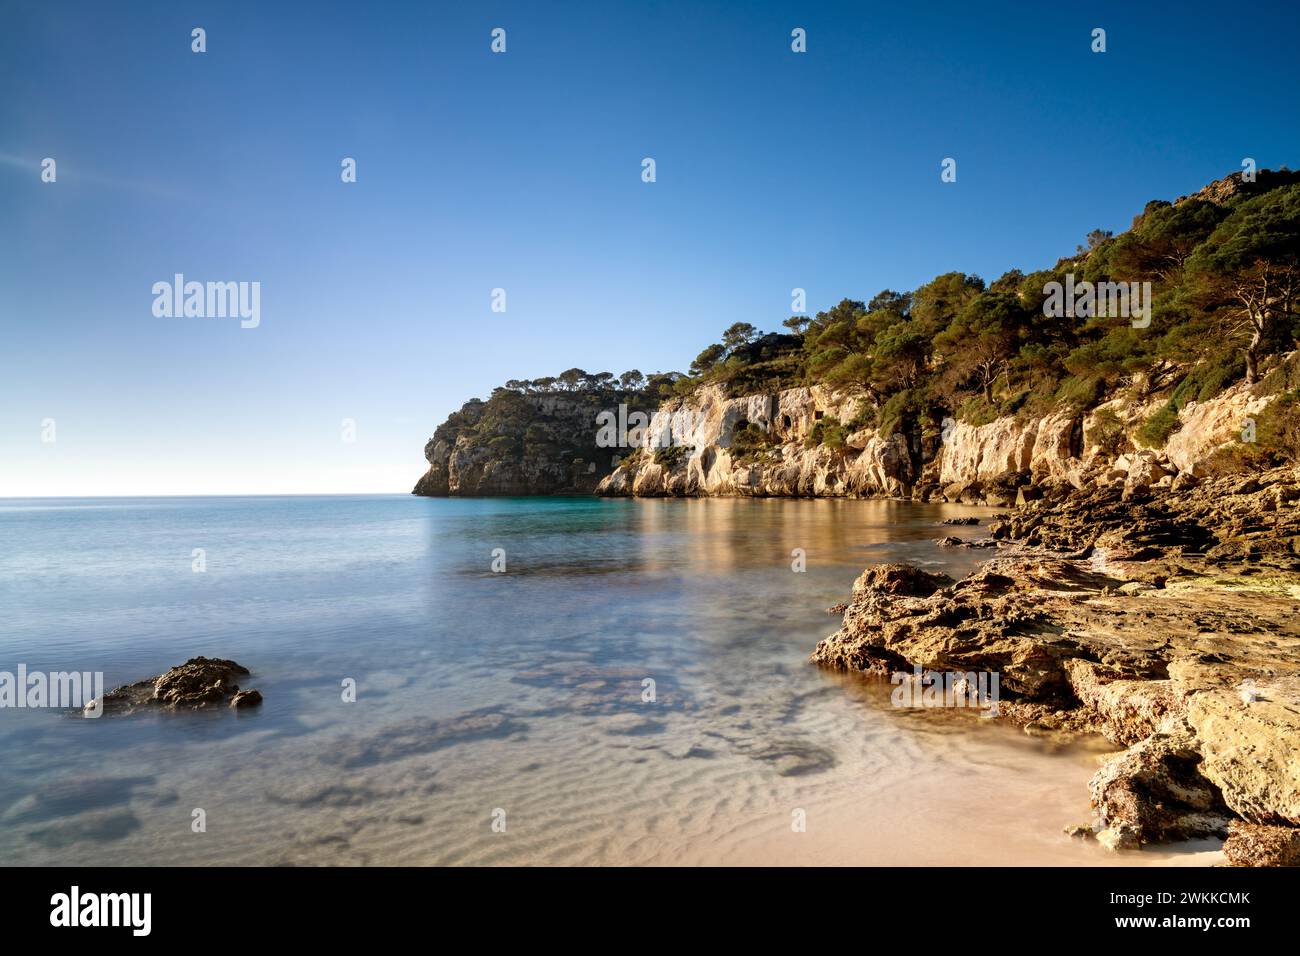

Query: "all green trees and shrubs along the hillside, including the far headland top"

xmin=434 ymin=168 xmax=1300 ymax=470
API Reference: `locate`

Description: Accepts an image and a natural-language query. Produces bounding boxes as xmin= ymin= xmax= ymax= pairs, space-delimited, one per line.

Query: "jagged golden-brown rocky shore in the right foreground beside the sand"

xmin=811 ymin=466 xmax=1300 ymax=866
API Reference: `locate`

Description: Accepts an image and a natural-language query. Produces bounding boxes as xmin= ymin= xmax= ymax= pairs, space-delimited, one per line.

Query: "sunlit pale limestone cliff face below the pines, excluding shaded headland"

xmin=595 ymin=374 xmax=1289 ymax=506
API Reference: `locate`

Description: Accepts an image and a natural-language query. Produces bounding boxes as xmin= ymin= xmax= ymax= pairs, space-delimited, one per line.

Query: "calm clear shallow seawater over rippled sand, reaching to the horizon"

xmin=0 ymin=496 xmax=1218 ymax=865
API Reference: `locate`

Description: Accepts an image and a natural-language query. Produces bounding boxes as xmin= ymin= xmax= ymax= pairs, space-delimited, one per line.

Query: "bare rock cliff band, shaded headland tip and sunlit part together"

xmin=415 ymin=355 xmax=1295 ymax=507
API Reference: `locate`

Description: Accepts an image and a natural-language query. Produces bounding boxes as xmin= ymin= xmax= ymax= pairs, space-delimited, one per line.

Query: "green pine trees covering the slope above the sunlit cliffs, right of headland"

xmin=660 ymin=169 xmax=1300 ymax=460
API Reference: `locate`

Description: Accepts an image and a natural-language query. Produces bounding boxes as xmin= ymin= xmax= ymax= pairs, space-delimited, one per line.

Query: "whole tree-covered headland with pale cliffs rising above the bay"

xmin=415 ymin=170 xmax=1300 ymax=507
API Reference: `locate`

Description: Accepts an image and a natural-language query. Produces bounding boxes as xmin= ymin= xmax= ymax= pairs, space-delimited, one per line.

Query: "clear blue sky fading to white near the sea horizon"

xmin=0 ymin=0 xmax=1300 ymax=497
